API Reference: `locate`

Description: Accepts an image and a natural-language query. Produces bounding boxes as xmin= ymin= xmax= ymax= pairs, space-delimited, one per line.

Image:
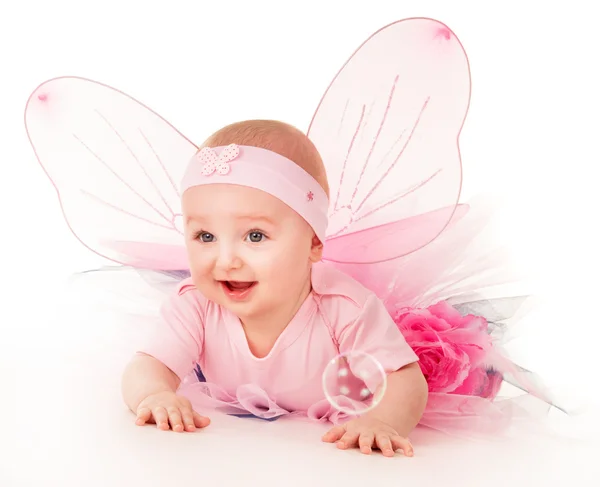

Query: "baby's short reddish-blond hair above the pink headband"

xmin=201 ymin=120 xmax=329 ymax=196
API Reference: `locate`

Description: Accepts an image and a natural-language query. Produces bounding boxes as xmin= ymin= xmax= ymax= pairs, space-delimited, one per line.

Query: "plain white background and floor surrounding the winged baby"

xmin=0 ymin=0 xmax=600 ymax=487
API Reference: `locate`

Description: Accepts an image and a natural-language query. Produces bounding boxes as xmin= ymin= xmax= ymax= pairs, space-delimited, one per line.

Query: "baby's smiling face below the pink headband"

xmin=182 ymin=184 xmax=320 ymax=321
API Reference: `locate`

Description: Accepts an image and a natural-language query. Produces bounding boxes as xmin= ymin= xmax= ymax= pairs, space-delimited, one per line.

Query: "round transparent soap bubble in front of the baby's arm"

xmin=323 ymin=351 xmax=387 ymax=415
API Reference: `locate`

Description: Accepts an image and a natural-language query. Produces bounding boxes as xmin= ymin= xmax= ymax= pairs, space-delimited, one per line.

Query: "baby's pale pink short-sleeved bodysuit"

xmin=139 ymin=263 xmax=418 ymax=422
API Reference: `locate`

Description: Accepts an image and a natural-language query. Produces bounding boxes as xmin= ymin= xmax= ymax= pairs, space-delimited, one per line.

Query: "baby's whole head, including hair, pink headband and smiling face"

xmin=182 ymin=120 xmax=329 ymax=321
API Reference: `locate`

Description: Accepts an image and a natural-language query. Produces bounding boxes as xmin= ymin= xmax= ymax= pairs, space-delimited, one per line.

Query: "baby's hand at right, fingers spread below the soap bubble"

xmin=322 ymin=416 xmax=413 ymax=457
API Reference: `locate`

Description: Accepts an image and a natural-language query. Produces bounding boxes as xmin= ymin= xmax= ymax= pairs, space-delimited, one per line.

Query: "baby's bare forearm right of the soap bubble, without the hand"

xmin=367 ymin=363 xmax=428 ymax=437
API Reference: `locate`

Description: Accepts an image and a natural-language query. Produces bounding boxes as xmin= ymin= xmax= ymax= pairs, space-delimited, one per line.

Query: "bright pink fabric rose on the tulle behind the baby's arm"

xmin=395 ymin=301 xmax=502 ymax=397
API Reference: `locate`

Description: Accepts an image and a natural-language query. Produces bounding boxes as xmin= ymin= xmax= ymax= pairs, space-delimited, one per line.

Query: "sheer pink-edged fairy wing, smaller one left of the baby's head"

xmin=25 ymin=77 xmax=197 ymax=270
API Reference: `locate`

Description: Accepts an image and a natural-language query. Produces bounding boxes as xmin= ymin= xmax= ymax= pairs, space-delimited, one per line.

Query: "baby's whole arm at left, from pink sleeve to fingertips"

xmin=121 ymin=293 xmax=210 ymax=431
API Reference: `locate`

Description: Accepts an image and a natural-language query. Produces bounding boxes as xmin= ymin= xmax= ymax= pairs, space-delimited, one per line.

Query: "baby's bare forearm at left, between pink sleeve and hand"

xmin=121 ymin=354 xmax=179 ymax=412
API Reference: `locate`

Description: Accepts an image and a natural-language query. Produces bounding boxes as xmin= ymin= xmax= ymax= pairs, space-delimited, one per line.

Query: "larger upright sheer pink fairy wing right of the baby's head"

xmin=308 ymin=19 xmax=471 ymax=263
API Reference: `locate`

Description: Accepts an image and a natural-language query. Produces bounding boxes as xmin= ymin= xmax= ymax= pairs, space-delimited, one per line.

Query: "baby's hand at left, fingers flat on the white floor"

xmin=135 ymin=392 xmax=210 ymax=432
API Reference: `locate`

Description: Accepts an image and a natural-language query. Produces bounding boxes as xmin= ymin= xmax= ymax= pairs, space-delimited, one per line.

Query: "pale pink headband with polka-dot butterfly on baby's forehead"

xmin=181 ymin=144 xmax=329 ymax=242
